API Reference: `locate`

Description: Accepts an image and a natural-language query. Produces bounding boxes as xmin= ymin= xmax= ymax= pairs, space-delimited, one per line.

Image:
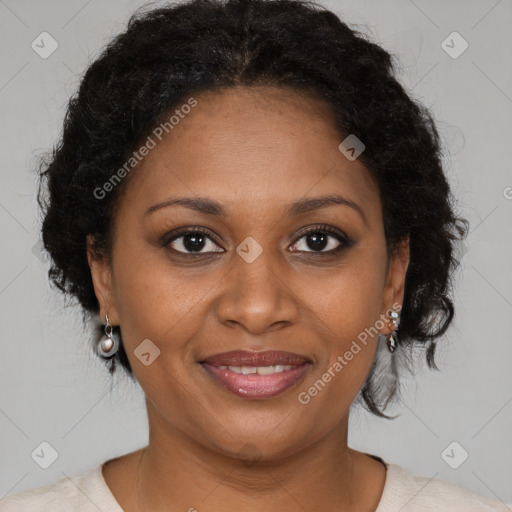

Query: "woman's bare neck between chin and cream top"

xmin=129 ymin=402 xmax=382 ymax=512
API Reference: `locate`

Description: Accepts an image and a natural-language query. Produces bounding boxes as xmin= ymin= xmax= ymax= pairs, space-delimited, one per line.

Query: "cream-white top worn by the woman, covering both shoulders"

xmin=0 ymin=456 xmax=512 ymax=512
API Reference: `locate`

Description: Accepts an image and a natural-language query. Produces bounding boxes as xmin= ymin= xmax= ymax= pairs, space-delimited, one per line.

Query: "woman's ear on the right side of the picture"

xmin=381 ymin=235 xmax=410 ymax=334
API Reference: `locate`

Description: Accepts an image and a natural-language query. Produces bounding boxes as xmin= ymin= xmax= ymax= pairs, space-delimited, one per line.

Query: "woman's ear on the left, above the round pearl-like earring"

xmin=87 ymin=235 xmax=119 ymax=326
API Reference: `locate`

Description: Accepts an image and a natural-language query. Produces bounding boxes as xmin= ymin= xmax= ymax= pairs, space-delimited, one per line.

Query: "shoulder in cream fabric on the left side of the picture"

xmin=0 ymin=463 xmax=123 ymax=512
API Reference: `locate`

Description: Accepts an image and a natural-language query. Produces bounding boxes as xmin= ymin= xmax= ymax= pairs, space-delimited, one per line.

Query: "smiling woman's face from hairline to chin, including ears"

xmin=89 ymin=87 xmax=408 ymax=459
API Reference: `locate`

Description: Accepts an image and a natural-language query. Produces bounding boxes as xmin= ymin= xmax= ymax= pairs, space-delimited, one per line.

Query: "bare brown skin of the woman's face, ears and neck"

xmin=88 ymin=86 xmax=409 ymax=512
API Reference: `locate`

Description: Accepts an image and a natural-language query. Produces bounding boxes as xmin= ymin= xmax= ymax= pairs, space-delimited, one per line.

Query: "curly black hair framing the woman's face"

xmin=38 ymin=0 xmax=469 ymax=418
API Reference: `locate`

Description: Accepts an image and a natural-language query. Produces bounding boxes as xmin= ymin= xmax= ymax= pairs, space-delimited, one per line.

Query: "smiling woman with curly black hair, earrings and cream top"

xmin=0 ymin=0 xmax=508 ymax=512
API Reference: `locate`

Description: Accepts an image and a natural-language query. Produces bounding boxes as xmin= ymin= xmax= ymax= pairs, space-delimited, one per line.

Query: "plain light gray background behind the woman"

xmin=0 ymin=0 xmax=512 ymax=502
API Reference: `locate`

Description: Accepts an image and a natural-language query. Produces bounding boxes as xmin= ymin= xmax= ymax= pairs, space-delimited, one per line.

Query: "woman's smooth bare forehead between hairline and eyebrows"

xmin=118 ymin=86 xmax=380 ymax=216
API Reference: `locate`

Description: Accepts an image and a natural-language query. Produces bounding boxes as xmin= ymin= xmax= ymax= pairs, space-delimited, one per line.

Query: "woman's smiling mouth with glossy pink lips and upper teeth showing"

xmin=200 ymin=350 xmax=312 ymax=399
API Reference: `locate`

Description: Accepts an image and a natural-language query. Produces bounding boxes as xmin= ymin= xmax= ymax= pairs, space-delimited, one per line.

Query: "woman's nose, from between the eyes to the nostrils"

xmin=216 ymin=245 xmax=300 ymax=335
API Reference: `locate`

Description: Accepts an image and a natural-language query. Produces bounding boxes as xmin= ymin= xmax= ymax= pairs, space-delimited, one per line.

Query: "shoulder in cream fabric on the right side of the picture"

xmin=376 ymin=463 xmax=512 ymax=512
